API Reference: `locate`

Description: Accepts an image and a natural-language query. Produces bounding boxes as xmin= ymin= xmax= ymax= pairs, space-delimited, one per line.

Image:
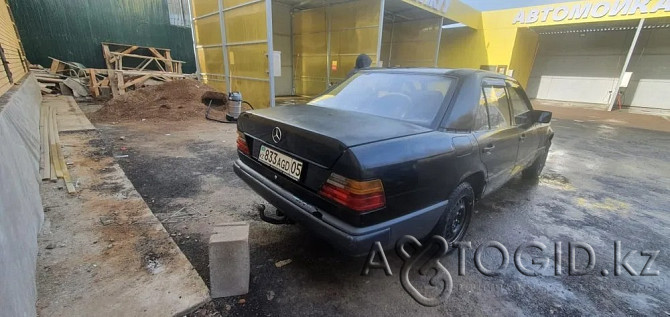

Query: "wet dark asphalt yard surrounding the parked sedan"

xmin=98 ymin=115 xmax=670 ymax=316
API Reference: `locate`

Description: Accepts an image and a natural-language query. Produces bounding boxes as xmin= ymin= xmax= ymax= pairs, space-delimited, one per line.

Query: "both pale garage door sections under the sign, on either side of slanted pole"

xmin=528 ymin=23 xmax=670 ymax=110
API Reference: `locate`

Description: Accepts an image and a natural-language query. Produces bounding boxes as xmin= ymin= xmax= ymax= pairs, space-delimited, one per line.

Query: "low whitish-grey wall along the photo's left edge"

xmin=0 ymin=75 xmax=44 ymax=316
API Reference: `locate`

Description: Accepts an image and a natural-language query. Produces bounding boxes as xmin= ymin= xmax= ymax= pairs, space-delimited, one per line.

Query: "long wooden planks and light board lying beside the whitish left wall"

xmin=40 ymin=96 xmax=95 ymax=194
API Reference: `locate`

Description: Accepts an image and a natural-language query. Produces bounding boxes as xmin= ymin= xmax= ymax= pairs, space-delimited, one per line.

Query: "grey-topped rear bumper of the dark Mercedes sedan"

xmin=233 ymin=160 xmax=447 ymax=256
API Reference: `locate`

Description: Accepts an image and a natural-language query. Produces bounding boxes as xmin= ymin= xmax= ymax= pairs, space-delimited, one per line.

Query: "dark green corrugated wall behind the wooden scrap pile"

xmin=9 ymin=0 xmax=195 ymax=73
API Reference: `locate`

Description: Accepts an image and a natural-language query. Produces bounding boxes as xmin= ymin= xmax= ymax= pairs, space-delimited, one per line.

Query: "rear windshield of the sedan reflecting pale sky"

xmin=308 ymin=72 xmax=453 ymax=126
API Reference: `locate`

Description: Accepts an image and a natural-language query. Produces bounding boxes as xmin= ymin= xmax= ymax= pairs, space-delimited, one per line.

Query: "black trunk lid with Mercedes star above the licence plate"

xmin=238 ymin=105 xmax=431 ymax=168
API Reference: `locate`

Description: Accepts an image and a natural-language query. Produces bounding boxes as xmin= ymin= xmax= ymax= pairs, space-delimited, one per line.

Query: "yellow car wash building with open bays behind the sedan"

xmin=192 ymin=0 xmax=670 ymax=109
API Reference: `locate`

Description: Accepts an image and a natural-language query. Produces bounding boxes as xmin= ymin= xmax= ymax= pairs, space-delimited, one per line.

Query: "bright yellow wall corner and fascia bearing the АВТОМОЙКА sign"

xmin=440 ymin=0 xmax=670 ymax=86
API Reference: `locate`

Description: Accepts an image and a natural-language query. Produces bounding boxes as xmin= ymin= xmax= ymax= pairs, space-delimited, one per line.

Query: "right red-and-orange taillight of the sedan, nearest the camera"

xmin=319 ymin=173 xmax=386 ymax=212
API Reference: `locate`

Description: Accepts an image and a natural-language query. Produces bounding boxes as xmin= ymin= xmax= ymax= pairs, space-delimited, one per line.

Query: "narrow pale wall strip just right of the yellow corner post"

xmin=272 ymin=2 xmax=293 ymax=96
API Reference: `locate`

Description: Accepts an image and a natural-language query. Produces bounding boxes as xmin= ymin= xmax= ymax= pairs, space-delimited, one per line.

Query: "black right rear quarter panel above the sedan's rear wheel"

xmin=333 ymin=131 xmax=482 ymax=226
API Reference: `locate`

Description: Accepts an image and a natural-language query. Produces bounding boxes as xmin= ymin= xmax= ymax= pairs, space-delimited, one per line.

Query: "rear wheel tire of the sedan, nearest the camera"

xmin=433 ymin=182 xmax=475 ymax=251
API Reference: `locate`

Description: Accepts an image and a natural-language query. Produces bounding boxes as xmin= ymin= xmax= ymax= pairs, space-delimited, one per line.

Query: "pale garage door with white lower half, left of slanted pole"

xmin=528 ymin=30 xmax=634 ymax=104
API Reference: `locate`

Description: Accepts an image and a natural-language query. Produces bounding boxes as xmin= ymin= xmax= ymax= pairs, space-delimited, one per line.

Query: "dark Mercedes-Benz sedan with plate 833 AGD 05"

xmin=234 ymin=69 xmax=553 ymax=255
